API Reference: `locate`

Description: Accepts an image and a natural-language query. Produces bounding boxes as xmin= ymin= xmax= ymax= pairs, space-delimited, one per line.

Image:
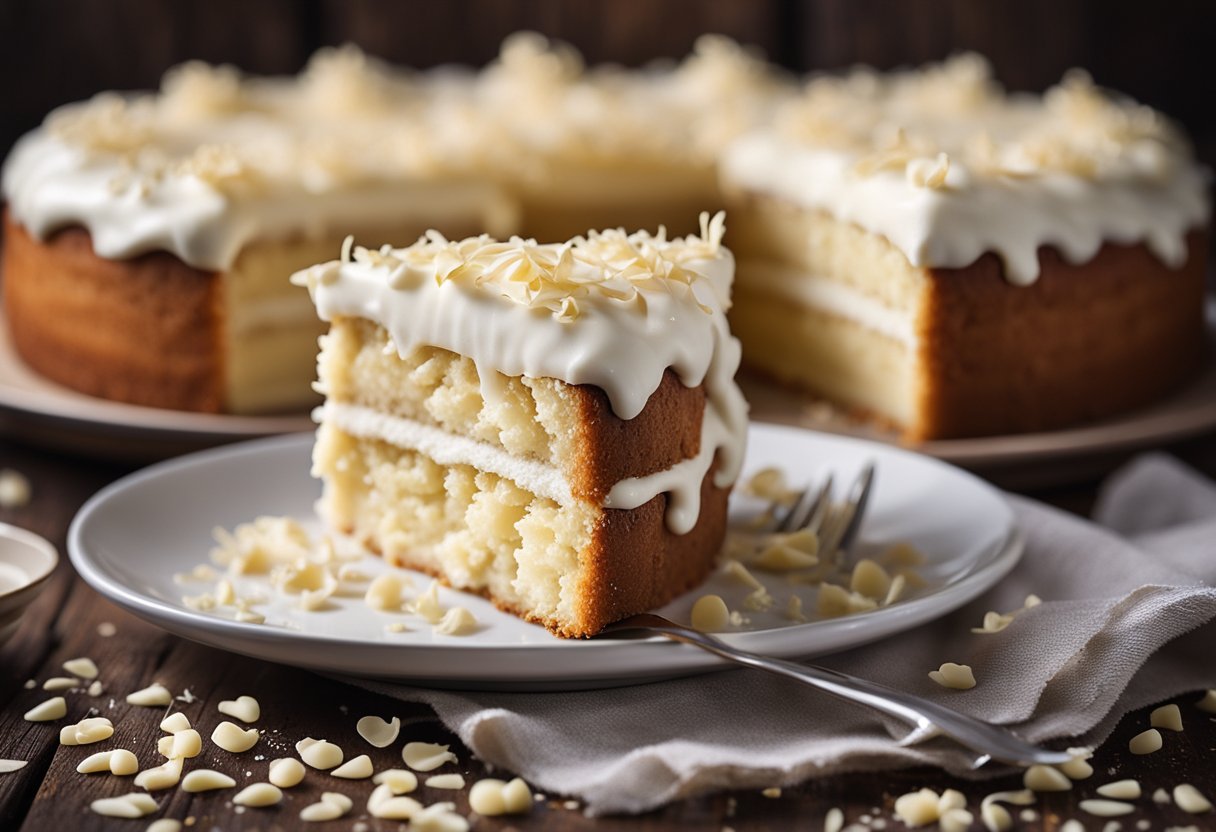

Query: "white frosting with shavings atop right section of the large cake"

xmin=720 ymin=56 xmax=1209 ymax=285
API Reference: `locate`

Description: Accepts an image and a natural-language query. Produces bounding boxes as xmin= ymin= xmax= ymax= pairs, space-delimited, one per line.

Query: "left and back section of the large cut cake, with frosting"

xmin=4 ymin=34 xmax=786 ymax=412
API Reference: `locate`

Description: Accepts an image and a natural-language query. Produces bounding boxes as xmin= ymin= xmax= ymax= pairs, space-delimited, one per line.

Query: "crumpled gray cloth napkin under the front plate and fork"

xmin=356 ymin=455 xmax=1216 ymax=814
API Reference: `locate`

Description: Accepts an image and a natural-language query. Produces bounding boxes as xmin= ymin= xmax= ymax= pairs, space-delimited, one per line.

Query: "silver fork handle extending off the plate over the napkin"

xmin=637 ymin=617 xmax=1071 ymax=765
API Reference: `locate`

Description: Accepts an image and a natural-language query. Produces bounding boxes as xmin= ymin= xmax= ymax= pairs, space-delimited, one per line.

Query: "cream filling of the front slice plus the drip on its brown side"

xmin=314 ymin=401 xmax=733 ymax=534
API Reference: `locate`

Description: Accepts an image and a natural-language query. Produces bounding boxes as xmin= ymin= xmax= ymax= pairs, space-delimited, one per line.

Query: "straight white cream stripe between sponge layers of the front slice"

xmin=314 ymin=401 xmax=571 ymax=505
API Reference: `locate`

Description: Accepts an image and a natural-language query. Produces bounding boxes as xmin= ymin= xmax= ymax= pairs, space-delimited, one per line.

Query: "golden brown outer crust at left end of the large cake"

xmin=4 ymin=212 xmax=225 ymax=412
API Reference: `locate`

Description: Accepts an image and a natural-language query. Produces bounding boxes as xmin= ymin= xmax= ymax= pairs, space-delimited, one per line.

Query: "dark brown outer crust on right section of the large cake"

xmin=908 ymin=231 xmax=1206 ymax=439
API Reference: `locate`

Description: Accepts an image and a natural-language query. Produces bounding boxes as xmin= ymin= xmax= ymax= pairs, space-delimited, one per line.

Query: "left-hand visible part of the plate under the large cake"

xmin=0 ymin=310 xmax=315 ymax=459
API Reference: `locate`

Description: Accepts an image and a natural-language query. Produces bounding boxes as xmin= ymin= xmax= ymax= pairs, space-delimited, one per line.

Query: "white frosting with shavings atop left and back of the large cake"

xmin=4 ymin=34 xmax=788 ymax=269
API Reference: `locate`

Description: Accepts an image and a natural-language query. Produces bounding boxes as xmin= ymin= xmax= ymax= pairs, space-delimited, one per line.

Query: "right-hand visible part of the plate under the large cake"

xmin=741 ymin=300 xmax=1216 ymax=488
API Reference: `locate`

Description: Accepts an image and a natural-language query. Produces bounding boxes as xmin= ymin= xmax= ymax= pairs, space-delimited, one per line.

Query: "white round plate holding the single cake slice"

xmin=68 ymin=425 xmax=1021 ymax=690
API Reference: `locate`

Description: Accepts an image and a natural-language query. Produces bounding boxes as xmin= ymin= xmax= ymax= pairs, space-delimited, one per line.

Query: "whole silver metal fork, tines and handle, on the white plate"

xmin=597 ymin=463 xmax=1071 ymax=768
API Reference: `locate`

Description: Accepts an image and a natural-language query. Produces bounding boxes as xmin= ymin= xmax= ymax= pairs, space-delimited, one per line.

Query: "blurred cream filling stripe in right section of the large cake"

xmin=739 ymin=260 xmax=917 ymax=348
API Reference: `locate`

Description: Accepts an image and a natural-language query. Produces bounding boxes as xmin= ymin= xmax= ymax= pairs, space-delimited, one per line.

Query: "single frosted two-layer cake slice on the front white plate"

xmin=294 ymin=215 xmax=747 ymax=636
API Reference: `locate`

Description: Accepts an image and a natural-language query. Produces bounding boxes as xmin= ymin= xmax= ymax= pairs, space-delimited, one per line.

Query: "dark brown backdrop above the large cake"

xmin=0 ymin=0 xmax=1216 ymax=162
